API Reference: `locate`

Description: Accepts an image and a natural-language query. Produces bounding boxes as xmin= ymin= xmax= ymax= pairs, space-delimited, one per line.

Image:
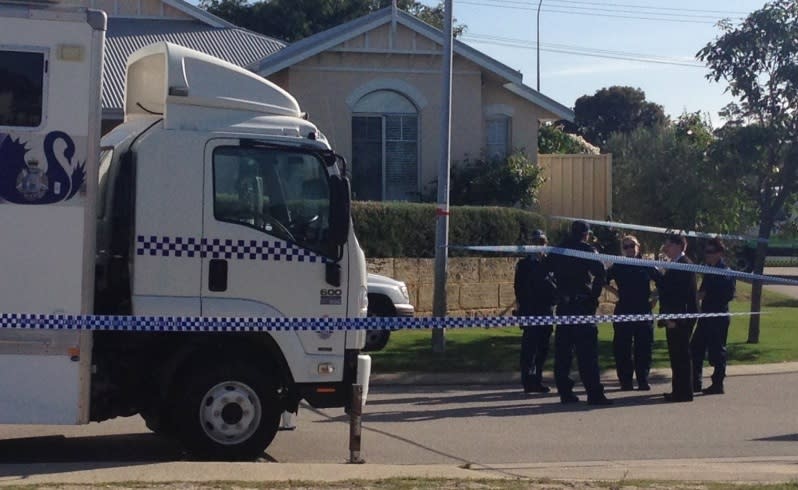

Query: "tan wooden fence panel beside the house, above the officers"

xmin=538 ymin=154 xmax=612 ymax=219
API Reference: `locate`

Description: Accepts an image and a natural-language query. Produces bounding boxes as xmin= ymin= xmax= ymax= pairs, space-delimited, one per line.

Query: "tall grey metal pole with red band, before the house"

xmin=432 ymin=0 xmax=452 ymax=352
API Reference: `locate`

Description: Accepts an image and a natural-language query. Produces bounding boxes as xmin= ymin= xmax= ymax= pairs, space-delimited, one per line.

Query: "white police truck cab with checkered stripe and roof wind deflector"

xmin=91 ymin=43 xmax=367 ymax=459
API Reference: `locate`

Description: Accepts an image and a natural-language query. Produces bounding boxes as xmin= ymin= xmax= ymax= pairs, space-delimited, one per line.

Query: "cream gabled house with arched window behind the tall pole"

xmin=255 ymin=7 xmax=573 ymax=201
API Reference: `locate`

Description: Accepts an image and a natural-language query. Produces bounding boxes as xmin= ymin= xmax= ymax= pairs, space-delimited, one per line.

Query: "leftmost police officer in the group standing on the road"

xmin=514 ymin=230 xmax=555 ymax=393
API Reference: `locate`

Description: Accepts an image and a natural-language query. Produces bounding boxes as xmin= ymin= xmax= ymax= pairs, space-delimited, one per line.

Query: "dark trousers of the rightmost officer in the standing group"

xmin=690 ymin=317 xmax=730 ymax=388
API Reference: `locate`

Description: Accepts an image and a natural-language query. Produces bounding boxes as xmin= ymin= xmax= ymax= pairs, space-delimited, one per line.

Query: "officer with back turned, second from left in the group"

xmin=549 ymin=221 xmax=612 ymax=405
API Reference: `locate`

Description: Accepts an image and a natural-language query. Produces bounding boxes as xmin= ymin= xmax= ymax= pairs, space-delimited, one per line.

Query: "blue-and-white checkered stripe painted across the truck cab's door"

xmin=136 ymin=235 xmax=327 ymax=263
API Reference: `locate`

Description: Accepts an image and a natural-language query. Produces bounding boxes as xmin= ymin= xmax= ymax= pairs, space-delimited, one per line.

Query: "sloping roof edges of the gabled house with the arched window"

xmin=252 ymin=7 xmax=574 ymax=121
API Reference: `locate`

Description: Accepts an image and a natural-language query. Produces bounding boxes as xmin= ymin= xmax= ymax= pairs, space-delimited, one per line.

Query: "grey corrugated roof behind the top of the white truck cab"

xmin=102 ymin=18 xmax=285 ymax=113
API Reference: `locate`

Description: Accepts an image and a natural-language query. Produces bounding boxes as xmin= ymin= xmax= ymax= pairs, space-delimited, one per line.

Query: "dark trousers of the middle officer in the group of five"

xmin=612 ymin=321 xmax=654 ymax=385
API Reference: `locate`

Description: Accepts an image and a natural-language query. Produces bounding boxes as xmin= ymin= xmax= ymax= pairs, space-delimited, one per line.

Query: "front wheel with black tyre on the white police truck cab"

xmin=172 ymin=363 xmax=282 ymax=461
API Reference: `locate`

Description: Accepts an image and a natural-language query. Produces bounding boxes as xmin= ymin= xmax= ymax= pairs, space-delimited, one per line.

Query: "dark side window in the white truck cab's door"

xmin=213 ymin=146 xmax=335 ymax=256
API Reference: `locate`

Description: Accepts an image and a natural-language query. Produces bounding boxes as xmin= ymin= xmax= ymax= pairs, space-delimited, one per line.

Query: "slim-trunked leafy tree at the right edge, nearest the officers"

xmin=696 ymin=0 xmax=798 ymax=343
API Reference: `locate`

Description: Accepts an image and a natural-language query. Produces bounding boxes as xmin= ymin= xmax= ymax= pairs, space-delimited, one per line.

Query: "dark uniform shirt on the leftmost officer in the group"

xmin=514 ymin=256 xmax=555 ymax=316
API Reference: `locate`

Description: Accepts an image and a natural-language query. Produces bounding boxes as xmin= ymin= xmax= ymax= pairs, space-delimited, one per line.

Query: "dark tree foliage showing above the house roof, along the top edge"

xmin=200 ymin=0 xmax=465 ymax=42
